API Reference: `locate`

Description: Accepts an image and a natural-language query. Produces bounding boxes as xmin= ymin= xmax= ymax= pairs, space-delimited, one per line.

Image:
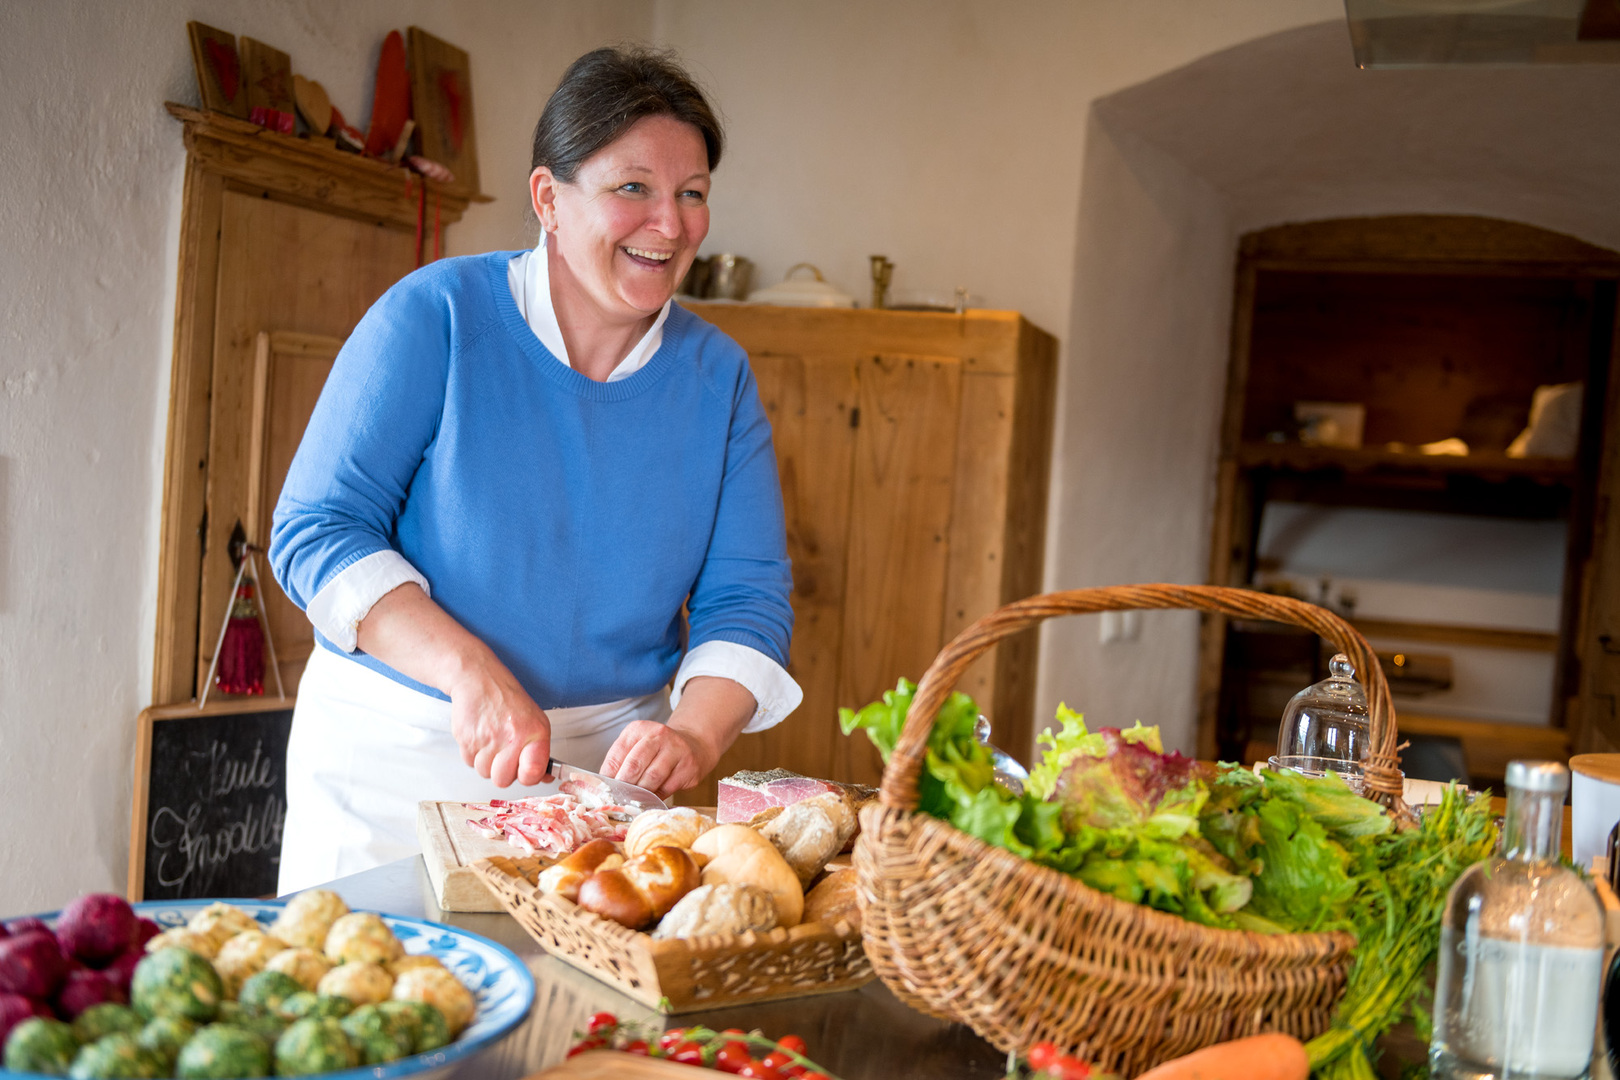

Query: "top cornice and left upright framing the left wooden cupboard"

xmin=152 ymin=102 xmax=489 ymax=704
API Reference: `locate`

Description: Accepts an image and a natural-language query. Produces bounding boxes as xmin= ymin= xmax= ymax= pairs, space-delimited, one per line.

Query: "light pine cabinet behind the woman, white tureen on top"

xmin=689 ymin=304 xmax=1056 ymax=793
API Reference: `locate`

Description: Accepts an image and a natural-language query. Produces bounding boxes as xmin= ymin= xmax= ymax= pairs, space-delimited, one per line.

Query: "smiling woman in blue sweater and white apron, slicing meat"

xmin=271 ymin=49 xmax=800 ymax=892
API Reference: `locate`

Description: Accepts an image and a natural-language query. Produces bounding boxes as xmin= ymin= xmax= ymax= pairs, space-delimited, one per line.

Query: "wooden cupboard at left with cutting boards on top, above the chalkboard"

xmin=152 ymin=105 xmax=488 ymax=704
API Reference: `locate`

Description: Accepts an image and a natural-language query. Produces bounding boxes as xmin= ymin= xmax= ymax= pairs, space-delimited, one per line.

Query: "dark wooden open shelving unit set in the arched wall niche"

xmin=1199 ymin=217 xmax=1620 ymax=780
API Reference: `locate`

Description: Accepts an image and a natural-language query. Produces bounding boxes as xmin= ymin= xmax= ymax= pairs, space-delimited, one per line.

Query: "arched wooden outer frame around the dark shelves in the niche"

xmin=1196 ymin=214 xmax=1620 ymax=758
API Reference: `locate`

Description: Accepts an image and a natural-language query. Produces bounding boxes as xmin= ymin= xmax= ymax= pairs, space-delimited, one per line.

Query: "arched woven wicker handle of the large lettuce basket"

xmin=883 ymin=585 xmax=1409 ymax=821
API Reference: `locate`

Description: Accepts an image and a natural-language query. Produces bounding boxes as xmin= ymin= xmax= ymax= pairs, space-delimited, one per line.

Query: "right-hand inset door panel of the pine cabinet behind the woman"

xmin=834 ymin=353 xmax=962 ymax=784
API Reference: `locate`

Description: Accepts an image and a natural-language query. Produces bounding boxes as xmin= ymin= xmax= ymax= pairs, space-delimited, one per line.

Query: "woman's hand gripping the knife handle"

xmin=449 ymin=656 xmax=551 ymax=787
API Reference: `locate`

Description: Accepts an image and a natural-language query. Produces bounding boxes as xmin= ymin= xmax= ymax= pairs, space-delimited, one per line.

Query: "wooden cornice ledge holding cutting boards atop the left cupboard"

xmin=164 ymin=102 xmax=494 ymax=230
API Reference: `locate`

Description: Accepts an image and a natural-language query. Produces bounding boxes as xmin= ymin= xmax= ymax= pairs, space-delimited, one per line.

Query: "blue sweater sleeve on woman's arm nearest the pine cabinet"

xmin=687 ymin=341 xmax=794 ymax=667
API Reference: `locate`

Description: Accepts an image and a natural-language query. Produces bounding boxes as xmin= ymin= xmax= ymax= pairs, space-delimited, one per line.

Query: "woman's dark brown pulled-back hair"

xmin=530 ymin=49 xmax=726 ymax=183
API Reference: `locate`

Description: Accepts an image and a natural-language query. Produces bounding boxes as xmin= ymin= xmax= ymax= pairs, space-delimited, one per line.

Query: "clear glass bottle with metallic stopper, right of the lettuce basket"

xmin=1429 ymin=761 xmax=1604 ymax=1080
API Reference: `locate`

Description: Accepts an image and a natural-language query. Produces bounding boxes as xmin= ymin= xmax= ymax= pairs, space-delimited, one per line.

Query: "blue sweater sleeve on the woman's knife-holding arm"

xmin=271 ymin=267 xmax=454 ymax=607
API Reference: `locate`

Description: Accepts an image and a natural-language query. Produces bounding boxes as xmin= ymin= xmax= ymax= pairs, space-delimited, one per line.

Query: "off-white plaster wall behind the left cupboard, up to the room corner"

xmin=0 ymin=0 xmax=651 ymax=913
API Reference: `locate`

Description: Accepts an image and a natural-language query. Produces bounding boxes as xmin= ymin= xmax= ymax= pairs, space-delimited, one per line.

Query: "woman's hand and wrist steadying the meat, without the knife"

xmin=601 ymin=675 xmax=758 ymax=795
